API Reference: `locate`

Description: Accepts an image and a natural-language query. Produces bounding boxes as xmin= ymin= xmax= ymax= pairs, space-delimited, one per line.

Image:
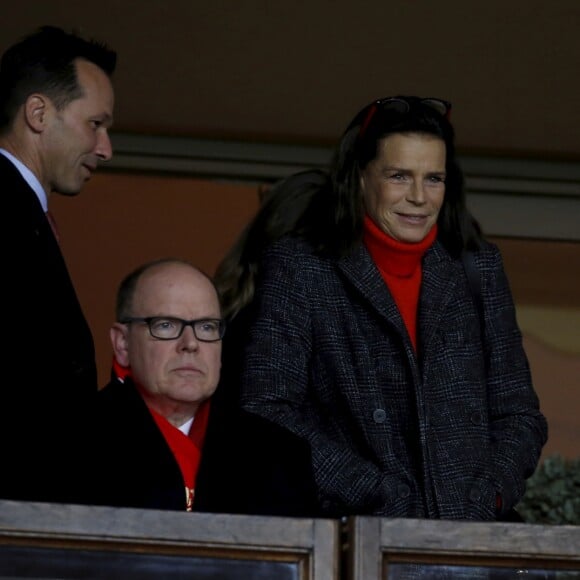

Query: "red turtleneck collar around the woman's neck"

xmin=363 ymin=215 xmax=437 ymax=278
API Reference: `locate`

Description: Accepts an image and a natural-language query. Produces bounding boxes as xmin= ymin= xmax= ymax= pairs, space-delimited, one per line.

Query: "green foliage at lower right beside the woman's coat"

xmin=516 ymin=455 xmax=580 ymax=525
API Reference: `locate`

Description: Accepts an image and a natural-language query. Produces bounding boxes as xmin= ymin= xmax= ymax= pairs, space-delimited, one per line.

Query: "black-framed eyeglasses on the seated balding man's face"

xmin=120 ymin=316 xmax=226 ymax=342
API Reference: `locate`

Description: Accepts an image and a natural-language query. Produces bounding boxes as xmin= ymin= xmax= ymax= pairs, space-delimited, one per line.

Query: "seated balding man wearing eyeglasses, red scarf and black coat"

xmin=79 ymin=258 xmax=314 ymax=515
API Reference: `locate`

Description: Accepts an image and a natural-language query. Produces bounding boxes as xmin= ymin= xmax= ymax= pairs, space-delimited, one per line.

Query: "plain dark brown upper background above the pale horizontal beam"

xmin=0 ymin=0 xmax=580 ymax=159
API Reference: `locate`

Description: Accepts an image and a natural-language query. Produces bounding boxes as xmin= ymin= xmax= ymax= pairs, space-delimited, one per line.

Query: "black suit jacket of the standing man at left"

xmin=0 ymin=155 xmax=98 ymax=501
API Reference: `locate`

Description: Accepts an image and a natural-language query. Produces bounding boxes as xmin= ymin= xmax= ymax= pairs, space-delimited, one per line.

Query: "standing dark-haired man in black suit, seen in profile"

xmin=0 ymin=27 xmax=116 ymax=501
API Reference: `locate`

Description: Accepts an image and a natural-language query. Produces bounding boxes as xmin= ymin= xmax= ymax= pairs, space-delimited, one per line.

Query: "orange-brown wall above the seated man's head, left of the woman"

xmin=50 ymin=173 xmax=258 ymax=385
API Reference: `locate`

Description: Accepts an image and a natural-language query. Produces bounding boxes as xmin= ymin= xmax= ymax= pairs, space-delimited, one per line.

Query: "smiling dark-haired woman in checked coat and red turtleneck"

xmin=218 ymin=96 xmax=547 ymax=520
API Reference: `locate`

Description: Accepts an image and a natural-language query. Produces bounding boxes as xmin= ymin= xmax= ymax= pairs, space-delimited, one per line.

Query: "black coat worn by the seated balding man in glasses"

xmin=79 ymin=378 xmax=314 ymax=516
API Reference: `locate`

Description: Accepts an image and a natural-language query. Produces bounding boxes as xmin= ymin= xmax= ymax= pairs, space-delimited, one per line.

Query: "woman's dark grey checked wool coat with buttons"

xmin=238 ymin=238 xmax=547 ymax=520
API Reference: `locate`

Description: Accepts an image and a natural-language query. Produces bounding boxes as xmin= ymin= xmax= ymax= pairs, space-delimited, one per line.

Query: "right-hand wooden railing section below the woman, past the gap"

xmin=347 ymin=517 xmax=580 ymax=580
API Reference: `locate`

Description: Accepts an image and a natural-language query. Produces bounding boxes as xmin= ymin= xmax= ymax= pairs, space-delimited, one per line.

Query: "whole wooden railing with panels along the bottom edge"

xmin=0 ymin=500 xmax=580 ymax=580
